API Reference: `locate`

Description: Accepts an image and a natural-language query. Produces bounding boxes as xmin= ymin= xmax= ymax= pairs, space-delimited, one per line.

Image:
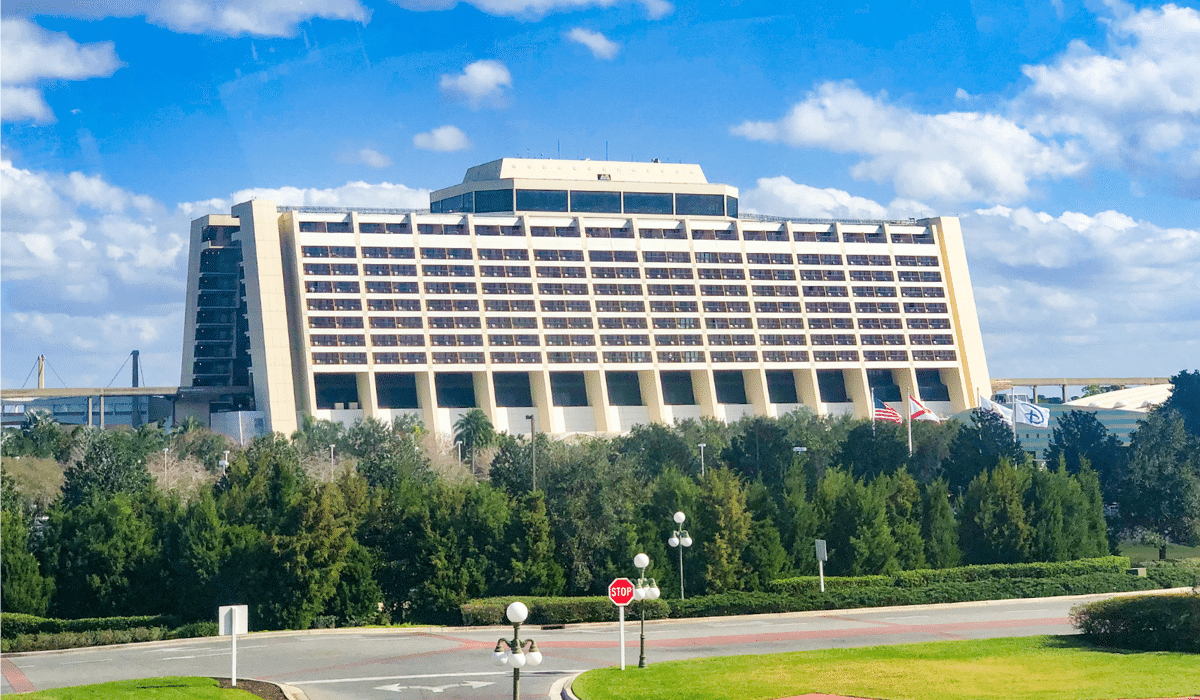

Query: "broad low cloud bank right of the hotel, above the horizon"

xmin=961 ymin=207 xmax=1200 ymax=376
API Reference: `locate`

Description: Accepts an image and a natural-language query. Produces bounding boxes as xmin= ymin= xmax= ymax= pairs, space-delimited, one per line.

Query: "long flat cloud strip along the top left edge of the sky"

xmin=5 ymin=0 xmax=371 ymax=36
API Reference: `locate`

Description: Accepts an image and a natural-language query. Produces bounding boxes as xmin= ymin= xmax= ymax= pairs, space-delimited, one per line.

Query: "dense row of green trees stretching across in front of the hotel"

xmin=2 ymin=372 xmax=1200 ymax=629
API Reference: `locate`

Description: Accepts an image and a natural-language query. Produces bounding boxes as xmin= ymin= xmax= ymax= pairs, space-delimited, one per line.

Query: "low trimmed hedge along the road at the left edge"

xmin=0 ymin=612 xmax=217 ymax=653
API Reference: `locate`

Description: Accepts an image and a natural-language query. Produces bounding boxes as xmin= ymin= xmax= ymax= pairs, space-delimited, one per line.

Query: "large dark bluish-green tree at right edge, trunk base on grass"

xmin=1121 ymin=409 xmax=1200 ymax=558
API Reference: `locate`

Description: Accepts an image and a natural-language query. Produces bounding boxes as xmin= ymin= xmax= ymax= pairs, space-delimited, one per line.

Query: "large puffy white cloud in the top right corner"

xmin=1014 ymin=2 xmax=1200 ymax=197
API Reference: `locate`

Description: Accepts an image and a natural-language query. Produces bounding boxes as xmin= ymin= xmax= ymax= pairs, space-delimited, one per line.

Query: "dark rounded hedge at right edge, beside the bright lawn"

xmin=1070 ymin=593 xmax=1200 ymax=652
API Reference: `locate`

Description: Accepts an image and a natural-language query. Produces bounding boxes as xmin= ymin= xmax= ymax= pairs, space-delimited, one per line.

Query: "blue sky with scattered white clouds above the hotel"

xmin=0 ymin=0 xmax=1200 ymax=388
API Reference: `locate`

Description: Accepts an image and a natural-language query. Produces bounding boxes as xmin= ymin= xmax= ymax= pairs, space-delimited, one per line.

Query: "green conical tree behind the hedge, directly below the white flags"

xmin=959 ymin=460 xmax=1031 ymax=564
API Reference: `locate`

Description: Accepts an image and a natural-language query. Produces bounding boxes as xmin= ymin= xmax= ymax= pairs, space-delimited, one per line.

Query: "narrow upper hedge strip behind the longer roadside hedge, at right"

xmin=770 ymin=557 xmax=1129 ymax=594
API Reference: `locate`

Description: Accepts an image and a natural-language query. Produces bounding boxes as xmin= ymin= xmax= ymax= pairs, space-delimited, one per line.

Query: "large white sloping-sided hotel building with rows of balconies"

xmin=181 ymin=158 xmax=990 ymax=435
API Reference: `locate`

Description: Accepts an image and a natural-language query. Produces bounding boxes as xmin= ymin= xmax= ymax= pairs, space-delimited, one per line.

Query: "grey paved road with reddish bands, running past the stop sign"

xmin=0 ymin=596 xmax=1132 ymax=700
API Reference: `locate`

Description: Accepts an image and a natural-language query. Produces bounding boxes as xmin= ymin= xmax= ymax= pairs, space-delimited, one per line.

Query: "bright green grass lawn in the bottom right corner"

xmin=572 ymin=636 xmax=1200 ymax=700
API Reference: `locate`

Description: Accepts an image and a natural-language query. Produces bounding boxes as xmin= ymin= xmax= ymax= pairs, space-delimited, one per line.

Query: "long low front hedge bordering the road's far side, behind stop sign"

xmin=462 ymin=572 xmax=1159 ymax=626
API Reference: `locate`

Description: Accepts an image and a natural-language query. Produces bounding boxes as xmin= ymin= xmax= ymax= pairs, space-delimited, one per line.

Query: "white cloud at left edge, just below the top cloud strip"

xmin=0 ymin=17 xmax=121 ymax=122
